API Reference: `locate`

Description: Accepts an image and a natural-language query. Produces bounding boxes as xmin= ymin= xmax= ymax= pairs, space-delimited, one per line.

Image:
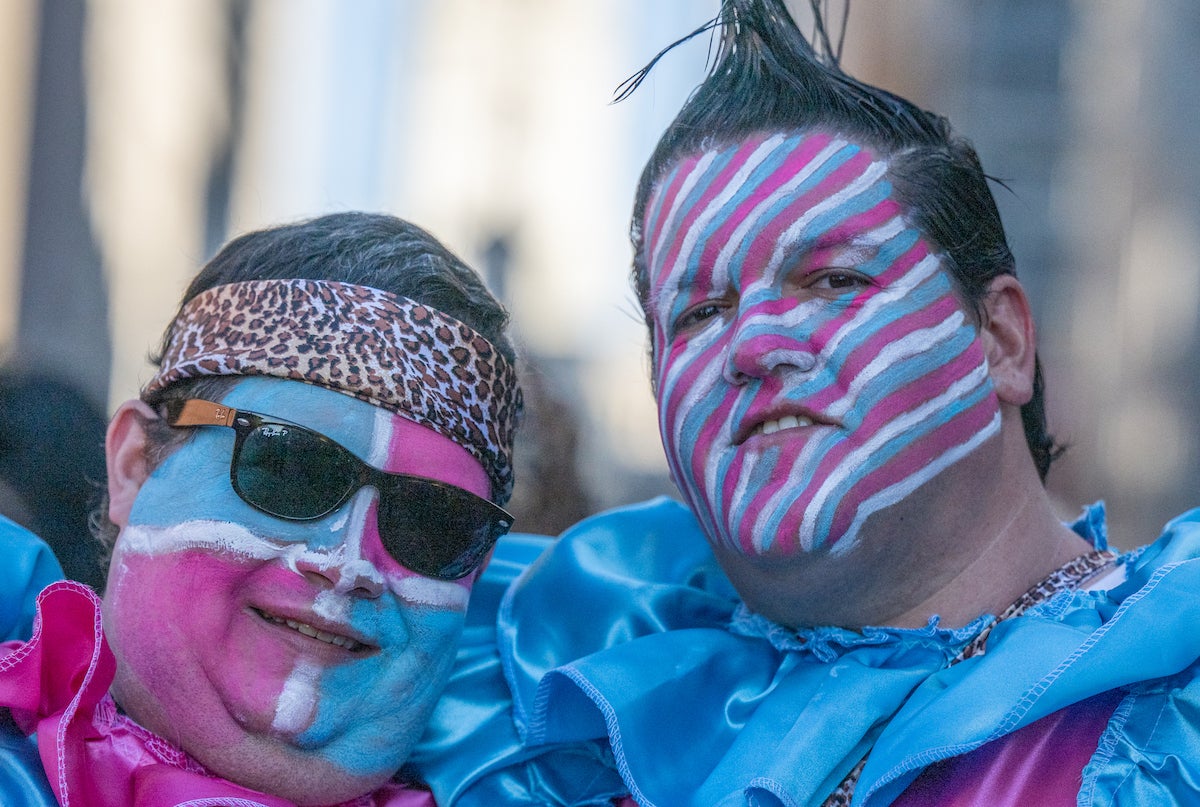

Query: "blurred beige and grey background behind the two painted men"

xmin=0 ymin=0 xmax=1200 ymax=579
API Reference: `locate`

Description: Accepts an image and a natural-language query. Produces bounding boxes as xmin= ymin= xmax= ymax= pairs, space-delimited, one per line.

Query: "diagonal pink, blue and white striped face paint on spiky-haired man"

xmin=643 ymin=132 xmax=1000 ymax=556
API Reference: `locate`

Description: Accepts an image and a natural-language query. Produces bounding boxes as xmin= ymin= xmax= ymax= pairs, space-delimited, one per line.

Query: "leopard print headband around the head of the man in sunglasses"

xmin=143 ymin=280 xmax=522 ymax=504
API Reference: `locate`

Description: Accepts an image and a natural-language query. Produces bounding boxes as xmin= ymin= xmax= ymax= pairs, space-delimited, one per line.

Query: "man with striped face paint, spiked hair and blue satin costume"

xmin=408 ymin=0 xmax=1200 ymax=807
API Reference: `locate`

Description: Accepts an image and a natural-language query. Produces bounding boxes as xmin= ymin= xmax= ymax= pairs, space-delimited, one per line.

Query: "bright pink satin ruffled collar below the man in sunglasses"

xmin=0 ymin=581 xmax=434 ymax=807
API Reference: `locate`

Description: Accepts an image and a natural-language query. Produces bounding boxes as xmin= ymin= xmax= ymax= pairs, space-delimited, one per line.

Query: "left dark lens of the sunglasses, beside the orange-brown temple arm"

xmin=233 ymin=423 xmax=355 ymax=520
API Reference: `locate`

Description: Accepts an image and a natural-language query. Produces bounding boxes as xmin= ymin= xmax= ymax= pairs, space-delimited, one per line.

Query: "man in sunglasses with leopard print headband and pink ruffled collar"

xmin=0 ymin=214 xmax=521 ymax=807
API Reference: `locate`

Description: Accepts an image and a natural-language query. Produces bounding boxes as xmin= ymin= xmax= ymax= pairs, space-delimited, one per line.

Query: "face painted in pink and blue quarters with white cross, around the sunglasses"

xmin=104 ymin=378 xmax=490 ymax=803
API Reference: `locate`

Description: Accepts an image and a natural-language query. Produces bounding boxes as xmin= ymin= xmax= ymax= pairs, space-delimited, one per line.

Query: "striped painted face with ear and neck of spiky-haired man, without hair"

xmin=641 ymin=128 xmax=1070 ymax=627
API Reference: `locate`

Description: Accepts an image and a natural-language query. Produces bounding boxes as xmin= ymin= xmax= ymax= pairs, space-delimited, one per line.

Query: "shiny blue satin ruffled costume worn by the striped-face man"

xmin=412 ymin=498 xmax=1200 ymax=807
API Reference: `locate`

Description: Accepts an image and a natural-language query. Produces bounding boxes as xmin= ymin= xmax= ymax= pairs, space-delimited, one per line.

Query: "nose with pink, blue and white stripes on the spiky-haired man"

xmin=724 ymin=310 xmax=817 ymax=384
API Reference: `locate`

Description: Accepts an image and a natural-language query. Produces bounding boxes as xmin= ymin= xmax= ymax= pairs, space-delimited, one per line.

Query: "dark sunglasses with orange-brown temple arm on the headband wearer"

xmin=167 ymin=399 xmax=512 ymax=580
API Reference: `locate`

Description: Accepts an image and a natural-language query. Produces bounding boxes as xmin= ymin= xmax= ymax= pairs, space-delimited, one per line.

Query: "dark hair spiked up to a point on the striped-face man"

xmin=618 ymin=0 xmax=1062 ymax=480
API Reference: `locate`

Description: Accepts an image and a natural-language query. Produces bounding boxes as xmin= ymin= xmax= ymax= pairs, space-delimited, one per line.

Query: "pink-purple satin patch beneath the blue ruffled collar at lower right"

xmin=892 ymin=692 xmax=1122 ymax=807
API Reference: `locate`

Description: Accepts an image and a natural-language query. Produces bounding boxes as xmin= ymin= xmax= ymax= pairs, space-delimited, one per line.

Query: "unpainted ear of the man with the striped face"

xmin=979 ymin=275 xmax=1037 ymax=406
